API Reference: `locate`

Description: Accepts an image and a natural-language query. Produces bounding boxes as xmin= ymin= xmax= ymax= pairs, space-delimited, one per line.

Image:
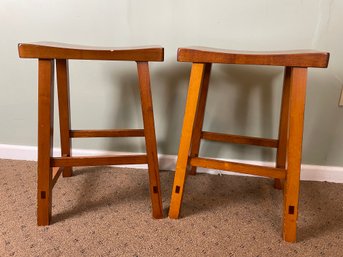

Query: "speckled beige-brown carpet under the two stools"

xmin=0 ymin=160 xmax=343 ymax=257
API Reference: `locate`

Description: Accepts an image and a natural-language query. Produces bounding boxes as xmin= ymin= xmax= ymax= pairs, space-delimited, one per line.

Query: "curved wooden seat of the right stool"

xmin=177 ymin=47 xmax=329 ymax=68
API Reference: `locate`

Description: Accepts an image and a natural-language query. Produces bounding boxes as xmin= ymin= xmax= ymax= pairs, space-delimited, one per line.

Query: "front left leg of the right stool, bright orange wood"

xmin=169 ymin=63 xmax=205 ymax=219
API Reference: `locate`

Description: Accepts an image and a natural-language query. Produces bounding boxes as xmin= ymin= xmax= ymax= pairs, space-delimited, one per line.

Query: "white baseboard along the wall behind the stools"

xmin=0 ymin=144 xmax=343 ymax=183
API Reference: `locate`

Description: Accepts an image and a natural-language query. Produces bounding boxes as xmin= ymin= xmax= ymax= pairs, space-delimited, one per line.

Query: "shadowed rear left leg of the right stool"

xmin=189 ymin=63 xmax=212 ymax=175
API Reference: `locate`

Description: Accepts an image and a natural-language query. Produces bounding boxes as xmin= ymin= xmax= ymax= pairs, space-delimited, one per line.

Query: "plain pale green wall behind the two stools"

xmin=0 ymin=0 xmax=343 ymax=166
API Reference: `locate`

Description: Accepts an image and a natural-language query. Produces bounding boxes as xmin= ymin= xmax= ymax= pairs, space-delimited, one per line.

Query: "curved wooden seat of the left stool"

xmin=18 ymin=42 xmax=164 ymax=62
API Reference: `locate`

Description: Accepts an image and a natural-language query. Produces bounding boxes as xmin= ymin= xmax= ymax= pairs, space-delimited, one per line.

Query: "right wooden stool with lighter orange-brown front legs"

xmin=169 ymin=47 xmax=329 ymax=242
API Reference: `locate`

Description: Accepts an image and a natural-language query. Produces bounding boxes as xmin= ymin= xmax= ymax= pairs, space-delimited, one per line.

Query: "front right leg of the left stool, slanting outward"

xmin=137 ymin=62 xmax=163 ymax=219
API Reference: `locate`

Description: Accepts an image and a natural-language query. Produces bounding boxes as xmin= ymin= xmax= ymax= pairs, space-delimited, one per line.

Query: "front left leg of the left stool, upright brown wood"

xmin=37 ymin=59 xmax=54 ymax=226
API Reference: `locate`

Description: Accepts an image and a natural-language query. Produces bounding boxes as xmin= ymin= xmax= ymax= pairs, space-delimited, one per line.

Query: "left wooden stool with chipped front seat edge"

xmin=18 ymin=42 xmax=164 ymax=225
